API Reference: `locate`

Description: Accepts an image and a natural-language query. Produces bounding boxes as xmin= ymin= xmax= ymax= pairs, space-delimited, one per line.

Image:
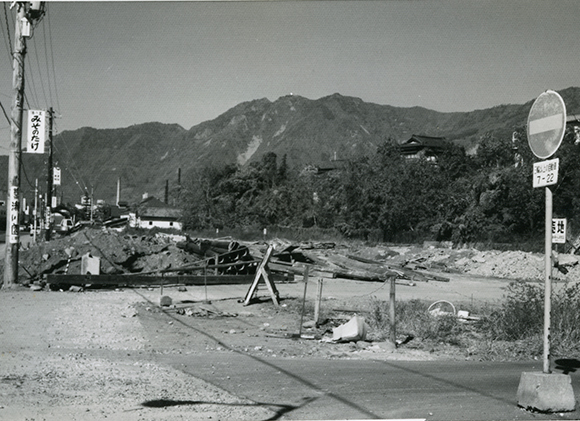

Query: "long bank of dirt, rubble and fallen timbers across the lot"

xmin=0 ymin=227 xmax=580 ymax=286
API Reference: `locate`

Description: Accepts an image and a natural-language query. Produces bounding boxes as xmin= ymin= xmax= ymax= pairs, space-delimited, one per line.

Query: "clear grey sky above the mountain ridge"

xmin=0 ymin=0 xmax=580 ymax=154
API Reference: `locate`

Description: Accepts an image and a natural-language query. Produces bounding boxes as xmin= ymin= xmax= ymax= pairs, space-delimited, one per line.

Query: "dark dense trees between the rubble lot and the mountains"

xmin=181 ymin=130 xmax=580 ymax=243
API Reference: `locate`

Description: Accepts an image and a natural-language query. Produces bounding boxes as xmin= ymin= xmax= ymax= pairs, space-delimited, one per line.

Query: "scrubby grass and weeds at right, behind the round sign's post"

xmin=358 ymin=281 xmax=580 ymax=360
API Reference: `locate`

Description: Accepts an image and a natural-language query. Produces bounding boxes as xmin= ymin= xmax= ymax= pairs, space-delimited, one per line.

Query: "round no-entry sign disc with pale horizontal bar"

xmin=527 ymin=90 xmax=566 ymax=159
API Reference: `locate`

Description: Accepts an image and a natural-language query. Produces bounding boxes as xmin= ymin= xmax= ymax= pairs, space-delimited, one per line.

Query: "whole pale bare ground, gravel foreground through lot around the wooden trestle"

xmin=0 ymin=270 xmax=516 ymax=420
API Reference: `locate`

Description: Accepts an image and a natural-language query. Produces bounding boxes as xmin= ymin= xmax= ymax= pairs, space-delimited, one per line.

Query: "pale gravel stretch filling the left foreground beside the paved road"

xmin=0 ymin=290 xmax=273 ymax=421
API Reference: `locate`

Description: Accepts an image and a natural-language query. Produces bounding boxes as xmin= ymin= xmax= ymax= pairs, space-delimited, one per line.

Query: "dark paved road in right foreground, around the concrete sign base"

xmin=154 ymin=353 xmax=580 ymax=420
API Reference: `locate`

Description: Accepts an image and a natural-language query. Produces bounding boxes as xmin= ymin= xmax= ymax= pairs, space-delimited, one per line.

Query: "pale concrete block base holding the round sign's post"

xmin=518 ymin=372 xmax=576 ymax=412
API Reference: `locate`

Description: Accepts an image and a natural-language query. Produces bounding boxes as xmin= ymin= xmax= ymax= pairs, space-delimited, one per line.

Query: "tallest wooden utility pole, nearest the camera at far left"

xmin=3 ymin=3 xmax=26 ymax=288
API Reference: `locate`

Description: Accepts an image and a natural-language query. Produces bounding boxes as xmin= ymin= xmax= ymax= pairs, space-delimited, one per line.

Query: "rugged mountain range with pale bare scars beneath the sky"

xmin=0 ymin=87 xmax=580 ymax=207
